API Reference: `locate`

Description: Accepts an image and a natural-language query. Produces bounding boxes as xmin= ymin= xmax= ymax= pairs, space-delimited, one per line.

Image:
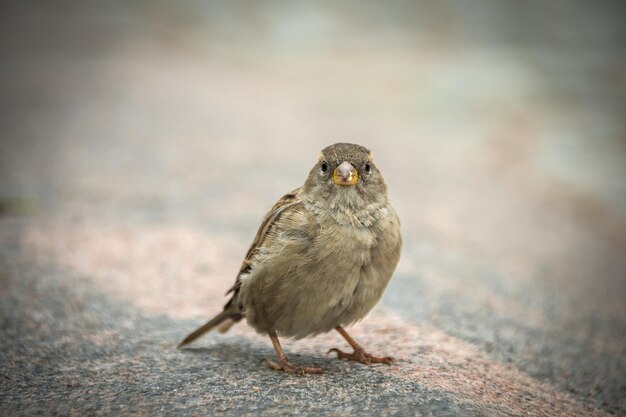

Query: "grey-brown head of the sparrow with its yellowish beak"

xmin=304 ymin=143 xmax=387 ymax=209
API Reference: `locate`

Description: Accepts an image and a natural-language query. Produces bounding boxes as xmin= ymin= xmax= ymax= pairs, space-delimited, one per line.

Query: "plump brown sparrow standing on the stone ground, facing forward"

xmin=179 ymin=143 xmax=402 ymax=374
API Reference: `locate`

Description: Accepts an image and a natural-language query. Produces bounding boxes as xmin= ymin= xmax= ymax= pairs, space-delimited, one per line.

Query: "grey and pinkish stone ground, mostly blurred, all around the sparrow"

xmin=0 ymin=1 xmax=626 ymax=416
